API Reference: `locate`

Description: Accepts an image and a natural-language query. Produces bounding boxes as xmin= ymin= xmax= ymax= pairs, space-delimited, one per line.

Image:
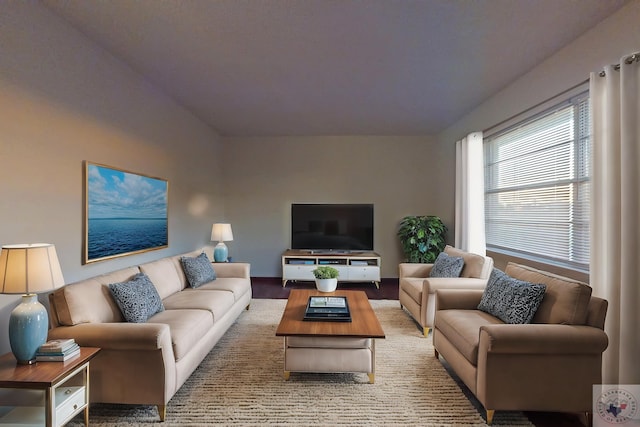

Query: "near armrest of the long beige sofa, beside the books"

xmin=48 ymin=322 xmax=171 ymax=350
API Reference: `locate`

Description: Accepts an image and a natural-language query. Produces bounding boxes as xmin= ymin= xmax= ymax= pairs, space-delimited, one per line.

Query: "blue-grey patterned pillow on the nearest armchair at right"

xmin=478 ymin=268 xmax=546 ymax=323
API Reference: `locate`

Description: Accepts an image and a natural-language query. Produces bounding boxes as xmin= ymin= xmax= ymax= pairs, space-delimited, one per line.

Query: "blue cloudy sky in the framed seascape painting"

xmin=87 ymin=164 xmax=167 ymax=219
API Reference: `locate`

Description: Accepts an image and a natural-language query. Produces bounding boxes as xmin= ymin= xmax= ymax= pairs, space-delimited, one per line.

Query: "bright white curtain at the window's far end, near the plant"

xmin=455 ymin=132 xmax=487 ymax=255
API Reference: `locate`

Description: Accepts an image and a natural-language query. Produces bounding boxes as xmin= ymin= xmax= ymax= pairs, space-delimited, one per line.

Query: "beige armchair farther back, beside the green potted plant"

xmin=398 ymin=245 xmax=493 ymax=337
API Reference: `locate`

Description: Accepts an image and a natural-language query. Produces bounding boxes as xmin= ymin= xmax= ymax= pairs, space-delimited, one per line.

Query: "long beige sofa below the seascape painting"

xmin=49 ymin=251 xmax=252 ymax=420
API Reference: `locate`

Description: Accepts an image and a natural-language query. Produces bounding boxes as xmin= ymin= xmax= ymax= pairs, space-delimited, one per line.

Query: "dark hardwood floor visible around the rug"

xmin=251 ymin=277 xmax=585 ymax=427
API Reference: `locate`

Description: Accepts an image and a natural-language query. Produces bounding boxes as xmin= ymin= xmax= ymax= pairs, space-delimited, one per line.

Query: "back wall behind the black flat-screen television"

xmin=223 ymin=136 xmax=440 ymax=277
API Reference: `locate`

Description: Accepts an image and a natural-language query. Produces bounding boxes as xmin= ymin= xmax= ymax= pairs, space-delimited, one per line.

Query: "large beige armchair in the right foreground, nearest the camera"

xmin=433 ymin=263 xmax=608 ymax=424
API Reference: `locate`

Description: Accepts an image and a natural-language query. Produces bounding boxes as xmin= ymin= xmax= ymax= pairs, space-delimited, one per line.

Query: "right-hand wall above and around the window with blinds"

xmin=434 ymin=0 xmax=640 ymax=280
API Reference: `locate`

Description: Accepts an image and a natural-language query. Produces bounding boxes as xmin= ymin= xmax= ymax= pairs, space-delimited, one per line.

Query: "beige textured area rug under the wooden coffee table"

xmin=69 ymin=299 xmax=533 ymax=427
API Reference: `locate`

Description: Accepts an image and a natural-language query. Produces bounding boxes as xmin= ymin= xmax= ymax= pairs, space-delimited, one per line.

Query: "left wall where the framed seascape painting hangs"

xmin=0 ymin=2 xmax=224 ymax=353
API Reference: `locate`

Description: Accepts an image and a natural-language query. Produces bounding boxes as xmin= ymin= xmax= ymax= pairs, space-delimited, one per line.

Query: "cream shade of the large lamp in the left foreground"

xmin=0 ymin=243 xmax=64 ymax=294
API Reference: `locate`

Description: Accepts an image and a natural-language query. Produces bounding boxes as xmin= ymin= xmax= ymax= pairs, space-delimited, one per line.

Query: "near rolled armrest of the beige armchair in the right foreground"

xmin=478 ymin=324 xmax=609 ymax=355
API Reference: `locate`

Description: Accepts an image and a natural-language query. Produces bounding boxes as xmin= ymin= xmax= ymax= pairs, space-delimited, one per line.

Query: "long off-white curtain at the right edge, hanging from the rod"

xmin=589 ymin=53 xmax=640 ymax=384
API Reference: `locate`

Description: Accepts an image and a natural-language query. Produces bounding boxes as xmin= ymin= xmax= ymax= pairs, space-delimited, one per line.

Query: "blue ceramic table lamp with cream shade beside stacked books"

xmin=0 ymin=243 xmax=64 ymax=364
